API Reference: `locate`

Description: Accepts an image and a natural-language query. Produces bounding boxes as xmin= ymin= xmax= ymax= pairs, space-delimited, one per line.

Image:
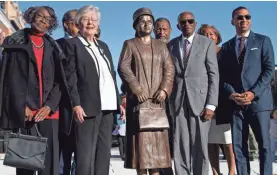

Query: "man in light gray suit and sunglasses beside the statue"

xmin=168 ymin=12 xmax=219 ymax=175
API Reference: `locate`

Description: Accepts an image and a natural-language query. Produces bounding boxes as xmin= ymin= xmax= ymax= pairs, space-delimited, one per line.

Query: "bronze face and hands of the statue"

xmin=136 ymin=15 xmax=167 ymax=103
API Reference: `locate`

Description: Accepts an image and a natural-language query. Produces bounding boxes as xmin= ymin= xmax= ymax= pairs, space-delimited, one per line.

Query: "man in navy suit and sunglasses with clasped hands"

xmin=219 ymin=7 xmax=275 ymax=175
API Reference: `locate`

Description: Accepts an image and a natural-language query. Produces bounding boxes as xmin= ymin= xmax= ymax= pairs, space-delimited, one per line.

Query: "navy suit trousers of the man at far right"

xmin=232 ymin=108 xmax=272 ymax=175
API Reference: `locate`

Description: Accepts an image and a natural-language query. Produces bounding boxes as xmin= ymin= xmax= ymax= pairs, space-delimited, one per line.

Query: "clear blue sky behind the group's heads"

xmin=19 ymin=1 xmax=277 ymax=87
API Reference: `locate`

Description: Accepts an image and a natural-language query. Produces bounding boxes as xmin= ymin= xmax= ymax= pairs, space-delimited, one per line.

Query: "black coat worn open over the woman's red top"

xmin=0 ymin=29 xmax=66 ymax=128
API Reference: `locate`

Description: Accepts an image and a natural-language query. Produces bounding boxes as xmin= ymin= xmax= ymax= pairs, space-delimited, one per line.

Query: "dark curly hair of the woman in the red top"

xmin=23 ymin=6 xmax=58 ymax=35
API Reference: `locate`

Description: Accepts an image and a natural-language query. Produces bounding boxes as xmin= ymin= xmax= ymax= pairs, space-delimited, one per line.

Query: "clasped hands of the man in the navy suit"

xmin=227 ymin=91 xmax=255 ymax=106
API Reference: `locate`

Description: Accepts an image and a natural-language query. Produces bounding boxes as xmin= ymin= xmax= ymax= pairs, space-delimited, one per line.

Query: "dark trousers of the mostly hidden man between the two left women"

xmin=59 ymin=126 xmax=76 ymax=175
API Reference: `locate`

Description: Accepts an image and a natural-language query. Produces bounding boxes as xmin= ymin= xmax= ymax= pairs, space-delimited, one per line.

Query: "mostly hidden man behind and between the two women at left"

xmin=57 ymin=9 xmax=78 ymax=175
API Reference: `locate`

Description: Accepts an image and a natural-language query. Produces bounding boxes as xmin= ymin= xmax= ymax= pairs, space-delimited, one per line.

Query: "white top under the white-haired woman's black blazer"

xmin=78 ymin=35 xmax=117 ymax=110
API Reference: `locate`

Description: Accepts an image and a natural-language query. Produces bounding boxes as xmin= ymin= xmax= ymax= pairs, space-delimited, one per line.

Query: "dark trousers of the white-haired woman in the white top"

xmin=75 ymin=111 xmax=113 ymax=175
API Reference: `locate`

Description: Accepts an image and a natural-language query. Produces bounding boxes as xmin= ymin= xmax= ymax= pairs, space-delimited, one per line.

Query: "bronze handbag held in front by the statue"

xmin=139 ymin=108 xmax=169 ymax=131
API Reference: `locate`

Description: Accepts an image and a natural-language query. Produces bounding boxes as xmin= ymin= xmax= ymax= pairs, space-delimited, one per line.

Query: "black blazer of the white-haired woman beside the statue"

xmin=59 ymin=37 xmax=121 ymax=135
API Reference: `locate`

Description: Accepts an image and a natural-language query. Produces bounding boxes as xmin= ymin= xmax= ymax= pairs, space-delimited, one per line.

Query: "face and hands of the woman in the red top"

xmin=25 ymin=8 xmax=52 ymax=122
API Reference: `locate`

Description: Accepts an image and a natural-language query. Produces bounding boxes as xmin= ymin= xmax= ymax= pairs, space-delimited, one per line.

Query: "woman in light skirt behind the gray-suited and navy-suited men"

xmin=198 ymin=24 xmax=235 ymax=175
